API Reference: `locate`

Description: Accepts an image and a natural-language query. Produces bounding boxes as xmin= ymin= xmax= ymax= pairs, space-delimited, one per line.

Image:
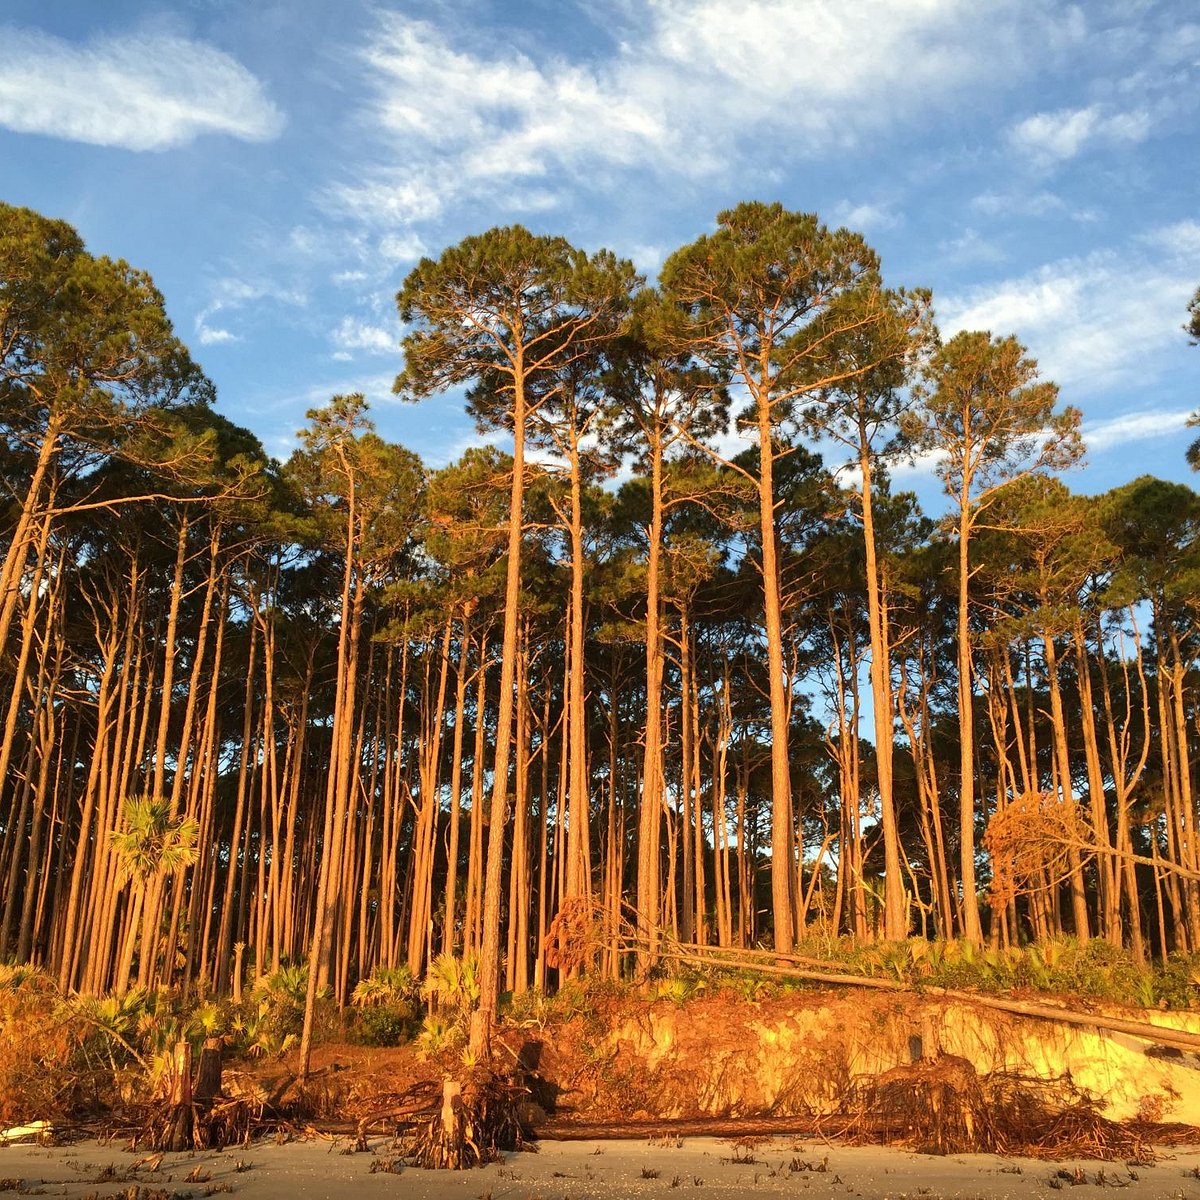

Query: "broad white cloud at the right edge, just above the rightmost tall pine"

xmin=938 ymin=241 xmax=1200 ymax=395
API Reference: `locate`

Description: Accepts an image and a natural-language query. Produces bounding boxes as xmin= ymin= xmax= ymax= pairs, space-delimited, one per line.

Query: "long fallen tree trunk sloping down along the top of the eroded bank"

xmin=630 ymin=940 xmax=1200 ymax=1054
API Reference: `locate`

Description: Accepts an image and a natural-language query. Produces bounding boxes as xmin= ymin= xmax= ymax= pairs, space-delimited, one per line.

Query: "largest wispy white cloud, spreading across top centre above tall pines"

xmin=340 ymin=0 xmax=1084 ymax=227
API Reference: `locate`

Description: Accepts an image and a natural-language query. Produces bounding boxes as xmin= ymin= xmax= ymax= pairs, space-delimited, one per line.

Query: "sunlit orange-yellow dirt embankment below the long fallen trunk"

xmin=508 ymin=990 xmax=1200 ymax=1124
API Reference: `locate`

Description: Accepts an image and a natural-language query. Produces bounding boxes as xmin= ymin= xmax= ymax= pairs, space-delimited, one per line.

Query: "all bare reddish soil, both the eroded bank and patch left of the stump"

xmin=216 ymin=989 xmax=1200 ymax=1159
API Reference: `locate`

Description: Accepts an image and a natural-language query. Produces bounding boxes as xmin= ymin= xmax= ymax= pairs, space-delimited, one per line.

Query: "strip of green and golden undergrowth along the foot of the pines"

xmin=0 ymin=938 xmax=1200 ymax=1123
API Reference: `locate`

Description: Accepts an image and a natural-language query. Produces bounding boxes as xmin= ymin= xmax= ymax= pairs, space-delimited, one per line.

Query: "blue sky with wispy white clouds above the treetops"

xmin=0 ymin=0 xmax=1200 ymax=508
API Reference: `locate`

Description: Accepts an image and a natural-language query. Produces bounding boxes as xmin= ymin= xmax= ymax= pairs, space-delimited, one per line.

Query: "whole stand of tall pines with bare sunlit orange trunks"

xmin=0 ymin=202 xmax=1200 ymax=1064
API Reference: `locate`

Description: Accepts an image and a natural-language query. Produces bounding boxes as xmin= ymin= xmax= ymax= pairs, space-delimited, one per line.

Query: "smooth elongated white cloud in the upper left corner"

xmin=0 ymin=26 xmax=284 ymax=150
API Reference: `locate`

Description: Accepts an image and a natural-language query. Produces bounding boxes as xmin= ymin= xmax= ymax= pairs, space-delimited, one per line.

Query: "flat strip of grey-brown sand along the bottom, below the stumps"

xmin=0 ymin=1138 xmax=1200 ymax=1200
